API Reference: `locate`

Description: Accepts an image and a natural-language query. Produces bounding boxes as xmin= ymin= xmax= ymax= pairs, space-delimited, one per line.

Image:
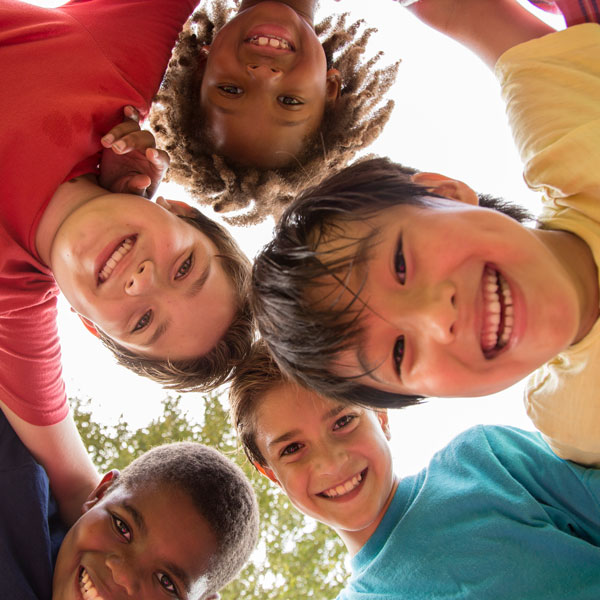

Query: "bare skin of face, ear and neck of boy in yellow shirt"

xmin=322 ymin=173 xmax=598 ymax=396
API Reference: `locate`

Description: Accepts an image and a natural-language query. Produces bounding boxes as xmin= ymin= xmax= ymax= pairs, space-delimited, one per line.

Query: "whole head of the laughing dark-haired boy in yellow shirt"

xmin=253 ymin=159 xmax=577 ymax=406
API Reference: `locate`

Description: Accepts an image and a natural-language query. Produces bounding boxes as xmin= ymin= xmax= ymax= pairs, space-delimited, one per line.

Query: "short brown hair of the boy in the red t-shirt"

xmin=97 ymin=210 xmax=254 ymax=392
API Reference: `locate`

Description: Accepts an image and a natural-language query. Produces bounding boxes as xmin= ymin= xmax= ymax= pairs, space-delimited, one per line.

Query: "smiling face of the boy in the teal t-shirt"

xmin=256 ymin=384 xmax=394 ymax=546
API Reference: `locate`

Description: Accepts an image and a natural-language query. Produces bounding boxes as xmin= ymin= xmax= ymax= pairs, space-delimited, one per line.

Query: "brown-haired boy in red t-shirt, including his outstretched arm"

xmin=0 ymin=0 xmax=252 ymax=524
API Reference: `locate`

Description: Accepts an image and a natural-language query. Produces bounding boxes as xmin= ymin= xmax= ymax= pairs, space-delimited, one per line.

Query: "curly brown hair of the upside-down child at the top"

xmin=150 ymin=0 xmax=400 ymax=225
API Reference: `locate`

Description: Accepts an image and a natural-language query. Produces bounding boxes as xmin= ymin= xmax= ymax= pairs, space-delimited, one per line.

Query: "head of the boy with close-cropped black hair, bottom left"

xmin=53 ymin=442 xmax=258 ymax=600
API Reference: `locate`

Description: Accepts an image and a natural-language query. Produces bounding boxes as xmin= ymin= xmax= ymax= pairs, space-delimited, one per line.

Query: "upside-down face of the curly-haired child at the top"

xmin=201 ymin=2 xmax=339 ymax=168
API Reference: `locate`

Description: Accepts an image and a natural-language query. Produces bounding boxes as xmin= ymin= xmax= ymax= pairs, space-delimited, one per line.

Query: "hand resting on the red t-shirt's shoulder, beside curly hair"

xmin=98 ymin=106 xmax=169 ymax=198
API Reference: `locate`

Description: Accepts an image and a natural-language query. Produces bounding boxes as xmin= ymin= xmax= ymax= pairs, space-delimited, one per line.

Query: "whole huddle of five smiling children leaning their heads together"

xmin=0 ymin=0 xmax=600 ymax=600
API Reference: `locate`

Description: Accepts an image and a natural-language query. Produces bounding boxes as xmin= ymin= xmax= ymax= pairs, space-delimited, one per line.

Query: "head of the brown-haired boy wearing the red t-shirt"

xmin=51 ymin=194 xmax=252 ymax=391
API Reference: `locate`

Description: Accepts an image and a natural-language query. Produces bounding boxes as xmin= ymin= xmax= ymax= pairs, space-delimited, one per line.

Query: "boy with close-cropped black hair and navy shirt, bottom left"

xmin=0 ymin=414 xmax=258 ymax=600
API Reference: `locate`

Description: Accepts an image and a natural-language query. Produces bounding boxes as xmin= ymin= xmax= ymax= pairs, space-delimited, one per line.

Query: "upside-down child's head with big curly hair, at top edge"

xmin=152 ymin=0 xmax=398 ymax=223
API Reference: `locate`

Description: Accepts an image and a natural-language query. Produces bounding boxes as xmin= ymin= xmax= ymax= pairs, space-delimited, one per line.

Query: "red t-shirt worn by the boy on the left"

xmin=0 ymin=0 xmax=198 ymax=425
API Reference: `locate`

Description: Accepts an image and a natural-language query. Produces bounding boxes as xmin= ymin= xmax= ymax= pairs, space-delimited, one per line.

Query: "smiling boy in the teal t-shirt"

xmin=231 ymin=344 xmax=600 ymax=600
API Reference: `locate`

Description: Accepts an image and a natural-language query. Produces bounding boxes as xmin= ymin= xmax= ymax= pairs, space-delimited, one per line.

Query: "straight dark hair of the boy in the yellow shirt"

xmin=252 ymin=158 xmax=530 ymax=408
